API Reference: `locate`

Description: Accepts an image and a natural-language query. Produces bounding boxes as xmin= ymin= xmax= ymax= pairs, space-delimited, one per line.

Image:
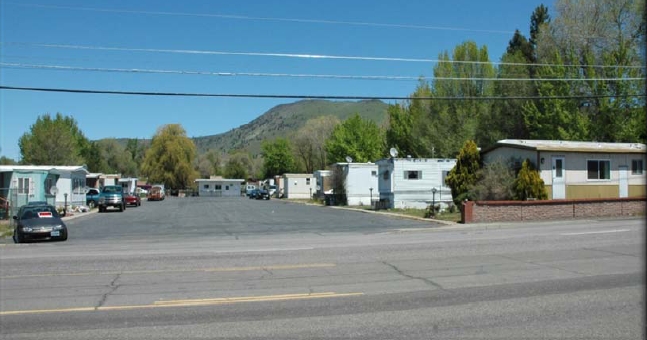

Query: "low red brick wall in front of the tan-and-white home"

xmin=462 ymin=197 xmax=647 ymax=223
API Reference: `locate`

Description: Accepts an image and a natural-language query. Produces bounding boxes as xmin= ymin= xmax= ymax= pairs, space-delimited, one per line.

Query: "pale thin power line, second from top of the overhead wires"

xmin=0 ymin=42 xmax=644 ymax=69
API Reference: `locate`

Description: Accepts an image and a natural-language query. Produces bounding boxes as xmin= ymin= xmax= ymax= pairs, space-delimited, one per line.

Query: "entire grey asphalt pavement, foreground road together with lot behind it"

xmin=0 ymin=198 xmax=645 ymax=339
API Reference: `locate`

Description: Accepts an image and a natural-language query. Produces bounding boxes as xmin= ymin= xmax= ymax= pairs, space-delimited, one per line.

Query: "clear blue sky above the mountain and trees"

xmin=0 ymin=0 xmax=554 ymax=160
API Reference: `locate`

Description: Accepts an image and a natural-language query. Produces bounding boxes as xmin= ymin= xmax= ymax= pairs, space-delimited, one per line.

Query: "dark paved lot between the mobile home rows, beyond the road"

xmin=62 ymin=197 xmax=435 ymax=242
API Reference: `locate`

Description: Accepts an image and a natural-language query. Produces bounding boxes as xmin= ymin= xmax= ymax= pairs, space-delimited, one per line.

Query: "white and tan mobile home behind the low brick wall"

xmin=481 ymin=139 xmax=647 ymax=199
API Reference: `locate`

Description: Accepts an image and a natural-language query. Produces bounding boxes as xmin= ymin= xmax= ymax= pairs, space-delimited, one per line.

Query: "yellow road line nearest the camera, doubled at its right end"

xmin=0 ymin=292 xmax=364 ymax=316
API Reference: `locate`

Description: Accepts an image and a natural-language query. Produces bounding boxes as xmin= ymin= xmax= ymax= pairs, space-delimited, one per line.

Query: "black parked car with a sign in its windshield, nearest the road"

xmin=13 ymin=204 xmax=67 ymax=243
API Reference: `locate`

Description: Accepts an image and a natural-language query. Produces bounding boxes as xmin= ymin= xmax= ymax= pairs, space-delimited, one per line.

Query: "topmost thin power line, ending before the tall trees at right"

xmin=2 ymin=3 xmax=514 ymax=34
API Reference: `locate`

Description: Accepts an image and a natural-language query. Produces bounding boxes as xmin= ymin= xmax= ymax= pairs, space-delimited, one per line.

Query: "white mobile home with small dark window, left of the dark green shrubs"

xmin=376 ymin=158 xmax=456 ymax=209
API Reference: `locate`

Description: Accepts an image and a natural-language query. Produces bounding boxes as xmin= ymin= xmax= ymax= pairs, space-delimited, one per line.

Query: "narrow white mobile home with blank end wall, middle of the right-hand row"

xmin=336 ymin=163 xmax=379 ymax=206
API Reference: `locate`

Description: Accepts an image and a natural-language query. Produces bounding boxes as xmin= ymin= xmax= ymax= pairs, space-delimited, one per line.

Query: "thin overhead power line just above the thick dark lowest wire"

xmin=0 ymin=62 xmax=645 ymax=82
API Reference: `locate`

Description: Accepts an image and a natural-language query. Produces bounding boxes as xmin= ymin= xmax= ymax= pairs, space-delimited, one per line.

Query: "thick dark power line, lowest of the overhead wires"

xmin=0 ymin=85 xmax=647 ymax=101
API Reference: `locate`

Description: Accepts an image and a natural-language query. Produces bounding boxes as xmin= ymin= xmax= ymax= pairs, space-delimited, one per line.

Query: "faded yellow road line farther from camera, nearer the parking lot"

xmin=0 ymin=263 xmax=336 ymax=279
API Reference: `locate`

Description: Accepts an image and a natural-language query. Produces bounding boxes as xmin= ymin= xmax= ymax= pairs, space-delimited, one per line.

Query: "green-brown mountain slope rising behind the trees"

xmin=193 ymin=100 xmax=388 ymax=155
